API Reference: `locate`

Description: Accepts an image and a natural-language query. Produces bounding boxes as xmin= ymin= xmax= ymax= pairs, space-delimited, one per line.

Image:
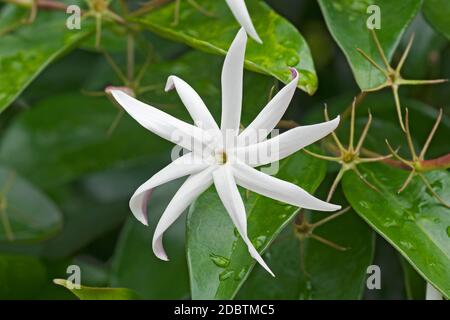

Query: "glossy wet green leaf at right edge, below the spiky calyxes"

xmin=343 ymin=164 xmax=450 ymax=297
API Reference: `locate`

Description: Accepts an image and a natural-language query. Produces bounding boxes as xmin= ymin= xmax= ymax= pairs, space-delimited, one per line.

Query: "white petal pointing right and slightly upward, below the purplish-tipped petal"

xmin=231 ymin=116 xmax=340 ymax=167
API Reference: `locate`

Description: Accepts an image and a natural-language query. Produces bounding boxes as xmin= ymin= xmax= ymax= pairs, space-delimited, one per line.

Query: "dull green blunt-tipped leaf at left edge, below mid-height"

xmin=0 ymin=167 xmax=62 ymax=243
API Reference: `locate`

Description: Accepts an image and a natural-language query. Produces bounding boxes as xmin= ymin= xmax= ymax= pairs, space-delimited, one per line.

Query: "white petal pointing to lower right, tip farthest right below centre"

xmin=233 ymin=163 xmax=341 ymax=211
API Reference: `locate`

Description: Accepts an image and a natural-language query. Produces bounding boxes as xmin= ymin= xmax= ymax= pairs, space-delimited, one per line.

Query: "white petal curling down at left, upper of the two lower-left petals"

xmin=130 ymin=153 xmax=208 ymax=225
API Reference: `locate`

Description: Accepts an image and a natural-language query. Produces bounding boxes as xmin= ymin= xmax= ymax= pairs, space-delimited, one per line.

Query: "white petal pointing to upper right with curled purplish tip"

xmin=239 ymin=68 xmax=299 ymax=143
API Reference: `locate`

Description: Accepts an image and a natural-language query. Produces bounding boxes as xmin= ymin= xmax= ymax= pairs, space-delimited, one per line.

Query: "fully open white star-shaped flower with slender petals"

xmin=109 ymin=29 xmax=340 ymax=275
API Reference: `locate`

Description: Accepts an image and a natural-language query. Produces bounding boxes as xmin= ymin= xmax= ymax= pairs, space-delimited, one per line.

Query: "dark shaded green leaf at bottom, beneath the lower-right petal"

xmin=237 ymin=192 xmax=375 ymax=300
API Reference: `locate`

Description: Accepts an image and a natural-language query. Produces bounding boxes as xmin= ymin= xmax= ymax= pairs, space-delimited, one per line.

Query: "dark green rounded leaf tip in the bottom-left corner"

xmin=0 ymin=254 xmax=47 ymax=299
